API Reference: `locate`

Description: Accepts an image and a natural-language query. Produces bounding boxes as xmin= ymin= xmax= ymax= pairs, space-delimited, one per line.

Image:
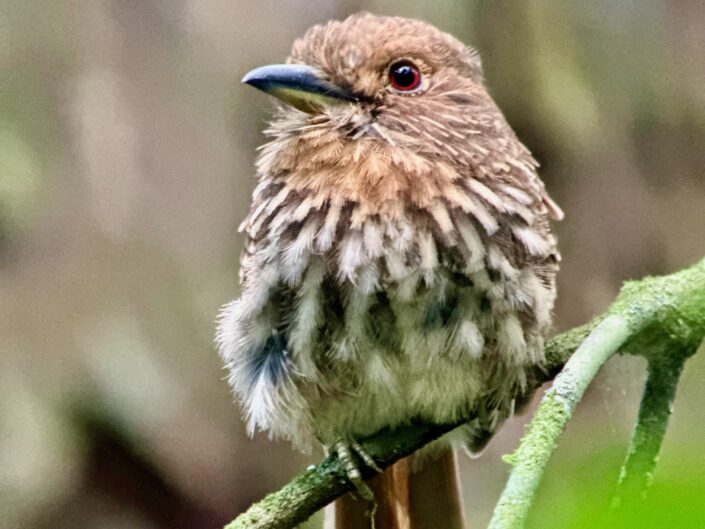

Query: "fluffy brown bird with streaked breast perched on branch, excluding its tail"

xmin=216 ymin=12 xmax=563 ymax=524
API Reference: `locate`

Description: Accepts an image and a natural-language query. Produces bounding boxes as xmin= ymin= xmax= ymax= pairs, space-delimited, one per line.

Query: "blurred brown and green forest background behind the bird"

xmin=0 ymin=0 xmax=705 ymax=529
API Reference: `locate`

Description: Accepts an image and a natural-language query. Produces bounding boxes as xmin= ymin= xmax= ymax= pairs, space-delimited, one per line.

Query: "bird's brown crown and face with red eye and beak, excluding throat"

xmin=243 ymin=13 xmax=482 ymax=114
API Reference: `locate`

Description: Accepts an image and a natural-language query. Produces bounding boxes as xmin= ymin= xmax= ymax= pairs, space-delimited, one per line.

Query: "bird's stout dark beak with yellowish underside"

xmin=242 ymin=64 xmax=358 ymax=114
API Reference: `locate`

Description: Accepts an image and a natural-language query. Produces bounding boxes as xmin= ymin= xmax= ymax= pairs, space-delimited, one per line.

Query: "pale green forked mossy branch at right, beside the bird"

xmin=489 ymin=255 xmax=705 ymax=529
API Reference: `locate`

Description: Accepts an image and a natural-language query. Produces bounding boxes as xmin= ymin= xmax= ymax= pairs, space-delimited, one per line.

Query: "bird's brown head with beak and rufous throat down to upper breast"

xmin=243 ymin=13 xmax=560 ymax=219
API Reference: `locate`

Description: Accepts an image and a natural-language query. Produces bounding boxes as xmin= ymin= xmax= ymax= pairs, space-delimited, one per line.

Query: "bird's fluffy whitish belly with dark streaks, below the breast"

xmin=219 ymin=227 xmax=554 ymax=448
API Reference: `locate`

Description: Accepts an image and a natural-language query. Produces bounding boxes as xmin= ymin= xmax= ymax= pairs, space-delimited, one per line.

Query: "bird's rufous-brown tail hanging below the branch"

xmin=325 ymin=449 xmax=465 ymax=529
